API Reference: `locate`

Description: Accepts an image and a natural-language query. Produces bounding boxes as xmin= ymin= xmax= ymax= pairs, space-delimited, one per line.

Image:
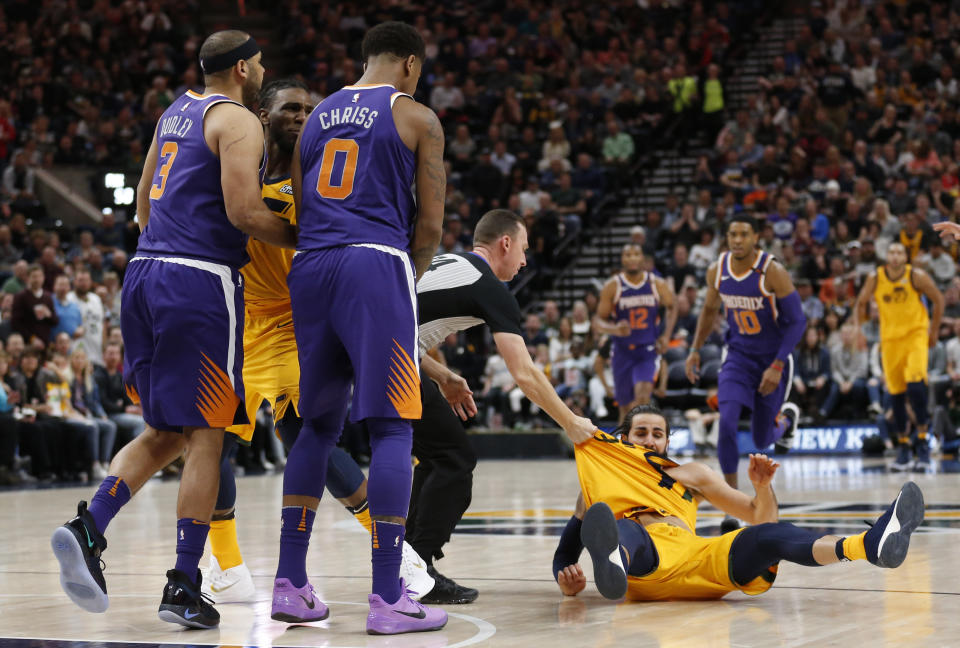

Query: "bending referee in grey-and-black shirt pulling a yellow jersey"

xmin=414 ymin=209 xmax=596 ymax=603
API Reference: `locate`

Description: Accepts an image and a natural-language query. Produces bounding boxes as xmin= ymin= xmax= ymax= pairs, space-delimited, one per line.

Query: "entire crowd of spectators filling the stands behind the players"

xmin=9 ymin=0 xmax=960 ymax=477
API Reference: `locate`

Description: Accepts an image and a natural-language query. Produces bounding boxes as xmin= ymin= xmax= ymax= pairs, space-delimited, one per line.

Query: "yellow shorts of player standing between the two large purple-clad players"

xmin=227 ymin=312 xmax=300 ymax=442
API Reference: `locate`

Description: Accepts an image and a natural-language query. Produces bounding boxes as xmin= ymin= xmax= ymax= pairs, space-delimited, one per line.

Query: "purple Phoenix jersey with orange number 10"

xmin=714 ymin=252 xmax=783 ymax=357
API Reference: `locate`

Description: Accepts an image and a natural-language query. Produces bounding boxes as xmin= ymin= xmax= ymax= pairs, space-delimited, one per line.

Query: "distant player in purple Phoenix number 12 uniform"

xmin=593 ymin=243 xmax=677 ymax=418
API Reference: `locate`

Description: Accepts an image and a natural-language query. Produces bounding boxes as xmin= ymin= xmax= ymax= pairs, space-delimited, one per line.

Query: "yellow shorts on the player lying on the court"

xmin=627 ymin=523 xmax=773 ymax=601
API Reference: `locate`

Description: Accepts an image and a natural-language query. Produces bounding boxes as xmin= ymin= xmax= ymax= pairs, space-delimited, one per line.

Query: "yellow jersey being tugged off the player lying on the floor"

xmin=576 ymin=430 xmax=697 ymax=531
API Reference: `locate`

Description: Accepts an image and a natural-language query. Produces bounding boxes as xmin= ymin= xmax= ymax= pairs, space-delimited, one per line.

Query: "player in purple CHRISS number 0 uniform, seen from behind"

xmin=271 ymin=22 xmax=447 ymax=634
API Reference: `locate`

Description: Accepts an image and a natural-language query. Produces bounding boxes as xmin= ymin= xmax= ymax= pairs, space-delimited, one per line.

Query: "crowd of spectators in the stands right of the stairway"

xmin=466 ymin=0 xmax=960 ymax=450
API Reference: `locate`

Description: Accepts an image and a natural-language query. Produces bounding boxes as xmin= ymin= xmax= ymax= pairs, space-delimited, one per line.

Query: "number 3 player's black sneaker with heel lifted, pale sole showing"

xmin=50 ymin=501 xmax=110 ymax=612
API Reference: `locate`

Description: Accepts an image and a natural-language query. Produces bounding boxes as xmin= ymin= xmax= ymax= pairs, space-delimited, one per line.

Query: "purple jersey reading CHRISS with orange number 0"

xmin=297 ymin=84 xmax=416 ymax=250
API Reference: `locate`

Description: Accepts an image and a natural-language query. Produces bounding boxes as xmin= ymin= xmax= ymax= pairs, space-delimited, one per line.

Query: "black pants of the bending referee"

xmin=406 ymin=377 xmax=477 ymax=563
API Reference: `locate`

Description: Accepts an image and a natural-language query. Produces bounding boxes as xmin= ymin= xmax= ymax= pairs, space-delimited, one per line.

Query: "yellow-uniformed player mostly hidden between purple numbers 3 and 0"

xmin=202 ymin=79 xmax=434 ymax=603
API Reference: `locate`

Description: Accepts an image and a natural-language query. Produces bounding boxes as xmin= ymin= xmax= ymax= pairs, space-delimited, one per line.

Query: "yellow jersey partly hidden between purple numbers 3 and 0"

xmin=240 ymin=176 xmax=297 ymax=316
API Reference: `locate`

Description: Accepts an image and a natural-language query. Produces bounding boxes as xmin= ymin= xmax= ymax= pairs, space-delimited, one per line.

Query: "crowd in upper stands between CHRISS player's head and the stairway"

xmin=280 ymin=0 xmax=763 ymax=271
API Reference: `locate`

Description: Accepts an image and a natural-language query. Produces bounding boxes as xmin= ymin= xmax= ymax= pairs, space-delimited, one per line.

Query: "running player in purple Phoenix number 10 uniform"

xmin=687 ymin=214 xmax=807 ymax=528
